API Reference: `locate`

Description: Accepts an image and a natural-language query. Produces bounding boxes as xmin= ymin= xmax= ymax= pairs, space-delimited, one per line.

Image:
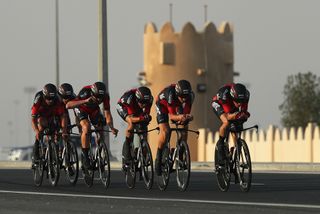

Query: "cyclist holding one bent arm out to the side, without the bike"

xmin=66 ymin=82 xmax=118 ymax=169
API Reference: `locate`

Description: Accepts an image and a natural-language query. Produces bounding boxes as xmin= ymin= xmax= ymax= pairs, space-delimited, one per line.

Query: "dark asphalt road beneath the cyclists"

xmin=0 ymin=169 xmax=320 ymax=214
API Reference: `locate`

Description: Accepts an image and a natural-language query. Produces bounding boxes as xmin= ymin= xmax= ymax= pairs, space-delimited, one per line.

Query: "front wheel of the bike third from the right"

xmin=140 ymin=141 xmax=154 ymax=189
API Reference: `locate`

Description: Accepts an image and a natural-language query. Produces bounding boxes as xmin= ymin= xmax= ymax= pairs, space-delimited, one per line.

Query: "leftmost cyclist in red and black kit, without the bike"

xmin=31 ymin=83 xmax=67 ymax=164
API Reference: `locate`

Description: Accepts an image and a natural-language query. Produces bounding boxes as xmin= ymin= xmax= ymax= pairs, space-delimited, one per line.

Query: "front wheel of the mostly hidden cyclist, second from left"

xmin=63 ymin=142 xmax=79 ymax=185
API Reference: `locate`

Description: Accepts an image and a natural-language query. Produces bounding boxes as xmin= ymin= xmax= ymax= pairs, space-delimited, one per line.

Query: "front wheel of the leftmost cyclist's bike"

xmin=48 ymin=142 xmax=60 ymax=186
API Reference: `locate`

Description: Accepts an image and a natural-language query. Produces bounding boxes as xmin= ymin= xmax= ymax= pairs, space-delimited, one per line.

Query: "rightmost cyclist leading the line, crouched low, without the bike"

xmin=212 ymin=83 xmax=250 ymax=166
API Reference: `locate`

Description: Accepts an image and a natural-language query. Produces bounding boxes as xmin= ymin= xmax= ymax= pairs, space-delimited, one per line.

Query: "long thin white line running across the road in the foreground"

xmin=0 ymin=190 xmax=320 ymax=209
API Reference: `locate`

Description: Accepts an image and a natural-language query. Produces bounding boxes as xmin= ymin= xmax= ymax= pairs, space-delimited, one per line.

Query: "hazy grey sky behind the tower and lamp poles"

xmin=0 ymin=0 xmax=320 ymax=152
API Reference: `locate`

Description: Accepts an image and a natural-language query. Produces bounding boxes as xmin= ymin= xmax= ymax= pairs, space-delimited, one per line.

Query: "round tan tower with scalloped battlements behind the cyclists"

xmin=144 ymin=22 xmax=234 ymax=160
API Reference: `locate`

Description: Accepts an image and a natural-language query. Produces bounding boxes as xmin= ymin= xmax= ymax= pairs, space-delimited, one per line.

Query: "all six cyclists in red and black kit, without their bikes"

xmin=31 ymin=80 xmax=250 ymax=187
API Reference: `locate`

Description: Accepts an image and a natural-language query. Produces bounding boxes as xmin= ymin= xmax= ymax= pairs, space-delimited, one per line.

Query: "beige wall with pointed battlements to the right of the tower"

xmin=197 ymin=123 xmax=320 ymax=163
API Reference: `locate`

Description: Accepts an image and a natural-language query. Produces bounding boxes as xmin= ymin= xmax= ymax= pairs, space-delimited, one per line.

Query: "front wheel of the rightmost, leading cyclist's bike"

xmin=236 ymin=139 xmax=252 ymax=192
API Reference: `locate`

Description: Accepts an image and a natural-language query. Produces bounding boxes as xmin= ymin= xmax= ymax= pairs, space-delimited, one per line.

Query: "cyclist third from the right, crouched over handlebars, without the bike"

xmin=117 ymin=86 xmax=153 ymax=167
